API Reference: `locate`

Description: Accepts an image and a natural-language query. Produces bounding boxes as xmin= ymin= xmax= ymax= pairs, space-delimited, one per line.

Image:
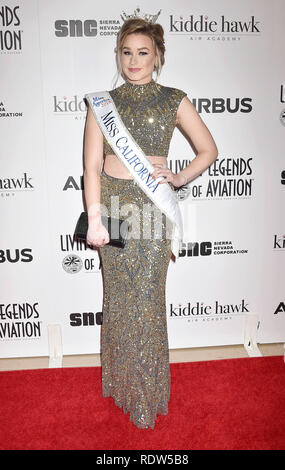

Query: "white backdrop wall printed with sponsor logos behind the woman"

xmin=0 ymin=0 xmax=285 ymax=357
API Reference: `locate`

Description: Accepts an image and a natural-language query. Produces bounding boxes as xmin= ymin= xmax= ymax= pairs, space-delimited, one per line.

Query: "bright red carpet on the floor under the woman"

xmin=0 ymin=356 xmax=285 ymax=450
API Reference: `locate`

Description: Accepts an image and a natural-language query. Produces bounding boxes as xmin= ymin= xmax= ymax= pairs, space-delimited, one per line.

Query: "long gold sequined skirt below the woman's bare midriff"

xmin=100 ymin=171 xmax=174 ymax=429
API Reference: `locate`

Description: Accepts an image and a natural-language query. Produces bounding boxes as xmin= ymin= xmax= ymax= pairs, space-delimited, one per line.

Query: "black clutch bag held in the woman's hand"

xmin=74 ymin=212 xmax=130 ymax=248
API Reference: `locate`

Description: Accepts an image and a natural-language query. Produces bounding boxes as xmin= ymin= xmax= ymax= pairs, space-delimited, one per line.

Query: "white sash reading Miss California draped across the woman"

xmin=85 ymin=91 xmax=183 ymax=259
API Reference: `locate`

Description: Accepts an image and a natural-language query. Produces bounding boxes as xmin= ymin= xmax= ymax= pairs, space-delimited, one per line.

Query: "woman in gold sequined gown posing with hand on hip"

xmin=84 ymin=18 xmax=217 ymax=429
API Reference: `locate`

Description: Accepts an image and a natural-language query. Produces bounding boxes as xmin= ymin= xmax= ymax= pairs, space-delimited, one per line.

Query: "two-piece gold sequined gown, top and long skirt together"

xmin=97 ymin=80 xmax=186 ymax=429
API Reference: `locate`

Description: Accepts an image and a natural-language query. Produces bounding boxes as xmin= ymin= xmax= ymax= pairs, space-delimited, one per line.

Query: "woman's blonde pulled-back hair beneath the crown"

xmin=113 ymin=18 xmax=165 ymax=88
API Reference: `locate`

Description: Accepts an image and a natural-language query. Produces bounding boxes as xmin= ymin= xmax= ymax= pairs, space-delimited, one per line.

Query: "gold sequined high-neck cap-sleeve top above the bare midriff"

xmin=104 ymin=79 xmax=186 ymax=157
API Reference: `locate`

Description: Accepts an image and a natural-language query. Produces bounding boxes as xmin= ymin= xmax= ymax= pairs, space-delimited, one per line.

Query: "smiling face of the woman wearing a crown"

xmin=121 ymin=33 xmax=156 ymax=85
